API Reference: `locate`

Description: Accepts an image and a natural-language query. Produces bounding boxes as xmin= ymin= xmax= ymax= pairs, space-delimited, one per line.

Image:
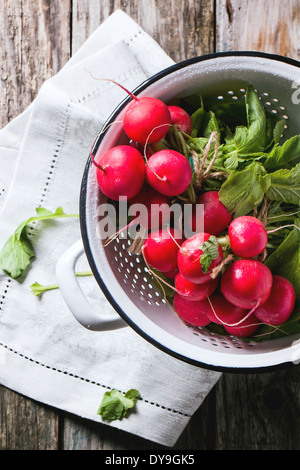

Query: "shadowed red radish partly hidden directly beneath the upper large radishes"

xmin=128 ymin=185 xmax=170 ymax=230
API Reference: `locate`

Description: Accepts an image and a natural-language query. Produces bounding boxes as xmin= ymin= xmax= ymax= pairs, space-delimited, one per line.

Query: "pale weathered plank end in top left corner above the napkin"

xmin=0 ymin=0 xmax=70 ymax=127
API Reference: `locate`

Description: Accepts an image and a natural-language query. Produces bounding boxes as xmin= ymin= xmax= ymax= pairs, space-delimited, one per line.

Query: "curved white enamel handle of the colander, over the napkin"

xmin=56 ymin=239 xmax=127 ymax=331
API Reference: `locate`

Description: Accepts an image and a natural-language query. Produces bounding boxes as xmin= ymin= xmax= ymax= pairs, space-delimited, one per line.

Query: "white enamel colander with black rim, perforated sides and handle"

xmin=57 ymin=52 xmax=300 ymax=371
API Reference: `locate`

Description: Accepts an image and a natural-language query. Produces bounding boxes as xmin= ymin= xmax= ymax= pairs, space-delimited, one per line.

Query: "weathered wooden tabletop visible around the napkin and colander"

xmin=0 ymin=0 xmax=300 ymax=450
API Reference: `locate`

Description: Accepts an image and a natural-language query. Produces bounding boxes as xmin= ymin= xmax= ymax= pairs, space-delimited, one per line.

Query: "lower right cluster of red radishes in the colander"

xmin=174 ymin=210 xmax=296 ymax=337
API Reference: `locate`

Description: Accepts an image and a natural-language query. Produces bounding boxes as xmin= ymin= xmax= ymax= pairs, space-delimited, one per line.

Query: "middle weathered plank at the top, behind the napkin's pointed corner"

xmin=72 ymin=0 xmax=214 ymax=62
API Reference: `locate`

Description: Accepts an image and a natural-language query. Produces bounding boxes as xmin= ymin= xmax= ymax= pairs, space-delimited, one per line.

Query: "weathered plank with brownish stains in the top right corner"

xmin=216 ymin=0 xmax=300 ymax=59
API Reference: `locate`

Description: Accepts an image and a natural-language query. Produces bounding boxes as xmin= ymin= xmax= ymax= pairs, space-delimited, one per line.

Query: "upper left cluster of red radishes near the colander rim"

xmin=91 ymin=92 xmax=192 ymax=201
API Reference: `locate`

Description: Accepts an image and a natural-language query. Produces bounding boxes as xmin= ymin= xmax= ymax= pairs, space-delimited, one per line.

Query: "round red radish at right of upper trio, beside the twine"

xmin=146 ymin=149 xmax=192 ymax=196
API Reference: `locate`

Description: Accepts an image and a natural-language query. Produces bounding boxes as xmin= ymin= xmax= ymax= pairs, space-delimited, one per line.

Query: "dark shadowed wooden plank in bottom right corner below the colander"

xmin=215 ymin=366 xmax=300 ymax=450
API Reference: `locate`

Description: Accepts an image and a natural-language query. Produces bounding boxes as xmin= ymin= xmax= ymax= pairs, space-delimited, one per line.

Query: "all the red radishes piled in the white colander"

xmin=92 ymin=85 xmax=296 ymax=337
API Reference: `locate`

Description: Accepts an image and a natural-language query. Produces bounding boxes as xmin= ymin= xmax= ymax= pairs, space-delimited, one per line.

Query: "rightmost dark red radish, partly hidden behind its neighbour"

xmin=254 ymin=275 xmax=296 ymax=325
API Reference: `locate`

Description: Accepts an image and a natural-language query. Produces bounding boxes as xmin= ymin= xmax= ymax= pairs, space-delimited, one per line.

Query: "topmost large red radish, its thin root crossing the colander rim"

xmin=123 ymin=97 xmax=171 ymax=144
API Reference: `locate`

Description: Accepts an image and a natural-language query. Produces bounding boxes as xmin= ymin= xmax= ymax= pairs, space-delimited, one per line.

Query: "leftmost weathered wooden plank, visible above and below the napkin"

xmin=0 ymin=0 xmax=71 ymax=450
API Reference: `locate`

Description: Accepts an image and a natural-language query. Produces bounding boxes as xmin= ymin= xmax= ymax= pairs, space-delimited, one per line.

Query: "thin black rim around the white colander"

xmin=79 ymin=51 xmax=300 ymax=373
